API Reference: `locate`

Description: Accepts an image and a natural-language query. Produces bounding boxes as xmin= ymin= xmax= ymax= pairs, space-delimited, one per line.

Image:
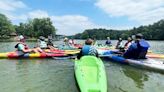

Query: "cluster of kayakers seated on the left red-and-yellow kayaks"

xmin=15 ymin=35 xmax=56 ymax=55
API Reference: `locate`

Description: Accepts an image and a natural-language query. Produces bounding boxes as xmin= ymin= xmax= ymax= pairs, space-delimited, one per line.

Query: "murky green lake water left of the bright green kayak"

xmin=0 ymin=59 xmax=77 ymax=92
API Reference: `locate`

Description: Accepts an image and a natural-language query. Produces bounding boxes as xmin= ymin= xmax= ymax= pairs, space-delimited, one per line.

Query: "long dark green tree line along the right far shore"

xmin=71 ymin=20 xmax=164 ymax=40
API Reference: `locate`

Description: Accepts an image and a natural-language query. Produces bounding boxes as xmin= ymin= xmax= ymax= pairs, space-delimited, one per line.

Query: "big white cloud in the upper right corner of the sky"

xmin=95 ymin=0 xmax=164 ymax=24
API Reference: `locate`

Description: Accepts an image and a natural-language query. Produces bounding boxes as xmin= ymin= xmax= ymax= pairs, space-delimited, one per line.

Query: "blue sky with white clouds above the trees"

xmin=0 ymin=0 xmax=164 ymax=35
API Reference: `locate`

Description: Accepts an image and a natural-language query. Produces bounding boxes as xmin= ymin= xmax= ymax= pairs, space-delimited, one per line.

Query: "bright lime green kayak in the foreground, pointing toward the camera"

xmin=74 ymin=56 xmax=107 ymax=92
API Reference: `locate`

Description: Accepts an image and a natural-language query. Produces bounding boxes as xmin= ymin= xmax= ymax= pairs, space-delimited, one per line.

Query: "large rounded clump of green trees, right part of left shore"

xmin=15 ymin=18 xmax=56 ymax=37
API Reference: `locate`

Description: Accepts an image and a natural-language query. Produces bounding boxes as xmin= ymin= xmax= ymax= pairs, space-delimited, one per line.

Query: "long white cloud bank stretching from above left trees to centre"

xmin=9 ymin=10 xmax=104 ymax=35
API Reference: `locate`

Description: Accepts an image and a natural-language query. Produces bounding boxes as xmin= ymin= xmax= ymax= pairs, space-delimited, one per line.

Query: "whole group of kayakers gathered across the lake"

xmin=15 ymin=34 xmax=150 ymax=59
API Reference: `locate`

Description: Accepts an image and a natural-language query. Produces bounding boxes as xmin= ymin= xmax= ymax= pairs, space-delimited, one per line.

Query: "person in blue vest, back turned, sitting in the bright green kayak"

xmin=77 ymin=38 xmax=98 ymax=59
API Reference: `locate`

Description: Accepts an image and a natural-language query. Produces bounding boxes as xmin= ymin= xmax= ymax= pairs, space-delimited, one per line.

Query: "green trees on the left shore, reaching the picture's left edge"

xmin=0 ymin=14 xmax=56 ymax=38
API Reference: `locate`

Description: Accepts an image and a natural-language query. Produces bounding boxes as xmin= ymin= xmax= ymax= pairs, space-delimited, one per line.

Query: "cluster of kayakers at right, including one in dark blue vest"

xmin=116 ymin=33 xmax=150 ymax=59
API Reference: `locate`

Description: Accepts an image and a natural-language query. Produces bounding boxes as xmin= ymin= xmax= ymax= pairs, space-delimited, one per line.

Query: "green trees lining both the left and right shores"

xmin=0 ymin=14 xmax=164 ymax=40
